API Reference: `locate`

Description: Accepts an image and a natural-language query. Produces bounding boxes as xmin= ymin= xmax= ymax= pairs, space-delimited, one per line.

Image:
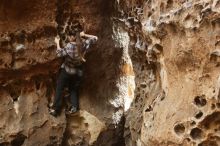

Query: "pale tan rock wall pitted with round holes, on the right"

xmin=115 ymin=0 xmax=220 ymax=146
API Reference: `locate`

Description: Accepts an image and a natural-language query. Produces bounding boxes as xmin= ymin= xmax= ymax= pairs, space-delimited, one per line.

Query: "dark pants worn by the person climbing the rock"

xmin=54 ymin=68 xmax=82 ymax=111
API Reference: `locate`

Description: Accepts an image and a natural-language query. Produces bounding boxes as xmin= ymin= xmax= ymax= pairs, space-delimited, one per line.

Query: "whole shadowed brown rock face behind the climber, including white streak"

xmin=0 ymin=0 xmax=127 ymax=146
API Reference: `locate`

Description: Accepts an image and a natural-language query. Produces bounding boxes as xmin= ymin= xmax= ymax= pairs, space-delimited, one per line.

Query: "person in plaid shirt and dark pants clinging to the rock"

xmin=49 ymin=30 xmax=98 ymax=117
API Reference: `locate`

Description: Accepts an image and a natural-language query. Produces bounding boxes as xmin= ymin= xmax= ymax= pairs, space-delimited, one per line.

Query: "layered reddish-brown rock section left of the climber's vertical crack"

xmin=0 ymin=0 xmax=66 ymax=146
